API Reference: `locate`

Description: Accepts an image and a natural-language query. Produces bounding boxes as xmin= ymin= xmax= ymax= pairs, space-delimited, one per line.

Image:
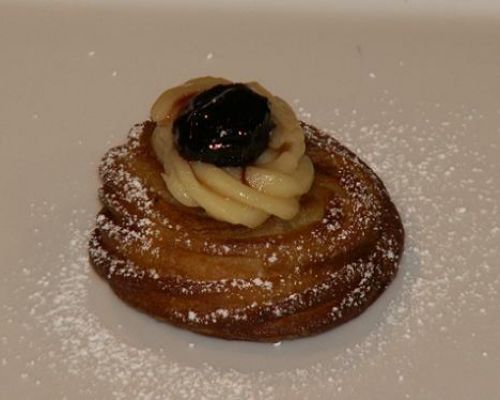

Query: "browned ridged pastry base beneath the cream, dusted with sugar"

xmin=89 ymin=121 xmax=404 ymax=341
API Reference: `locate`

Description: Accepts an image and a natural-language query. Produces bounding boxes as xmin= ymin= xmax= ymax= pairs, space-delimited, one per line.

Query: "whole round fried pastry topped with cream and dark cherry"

xmin=89 ymin=77 xmax=404 ymax=341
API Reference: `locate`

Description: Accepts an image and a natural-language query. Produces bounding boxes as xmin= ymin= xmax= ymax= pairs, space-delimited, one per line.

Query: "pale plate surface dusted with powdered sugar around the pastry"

xmin=0 ymin=1 xmax=500 ymax=400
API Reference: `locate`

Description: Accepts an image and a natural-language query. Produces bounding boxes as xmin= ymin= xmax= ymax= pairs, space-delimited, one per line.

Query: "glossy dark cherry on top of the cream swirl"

xmin=174 ymin=83 xmax=274 ymax=167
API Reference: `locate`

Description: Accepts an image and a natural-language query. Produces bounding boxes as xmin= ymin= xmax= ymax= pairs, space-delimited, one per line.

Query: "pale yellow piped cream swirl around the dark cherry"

xmin=151 ymin=77 xmax=314 ymax=228
